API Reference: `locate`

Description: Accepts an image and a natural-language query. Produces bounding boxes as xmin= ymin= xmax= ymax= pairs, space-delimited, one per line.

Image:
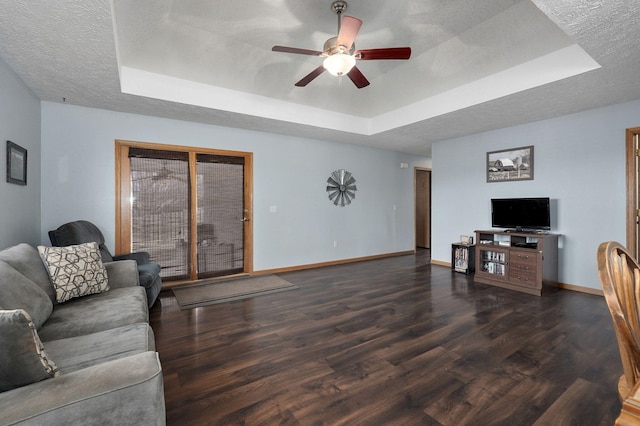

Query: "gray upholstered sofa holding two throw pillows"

xmin=0 ymin=244 xmax=166 ymax=425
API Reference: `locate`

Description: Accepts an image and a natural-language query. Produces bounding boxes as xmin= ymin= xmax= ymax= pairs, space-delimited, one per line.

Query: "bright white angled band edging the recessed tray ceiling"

xmin=120 ymin=44 xmax=600 ymax=136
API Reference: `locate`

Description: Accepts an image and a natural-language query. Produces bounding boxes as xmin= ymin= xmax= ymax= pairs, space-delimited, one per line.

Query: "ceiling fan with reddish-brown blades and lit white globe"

xmin=271 ymin=0 xmax=411 ymax=89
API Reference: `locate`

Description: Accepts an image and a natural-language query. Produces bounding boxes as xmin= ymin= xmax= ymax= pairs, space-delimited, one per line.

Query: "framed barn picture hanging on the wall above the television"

xmin=486 ymin=146 xmax=533 ymax=182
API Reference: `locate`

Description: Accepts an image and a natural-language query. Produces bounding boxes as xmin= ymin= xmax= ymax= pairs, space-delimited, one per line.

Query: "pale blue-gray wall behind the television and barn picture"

xmin=432 ymin=101 xmax=640 ymax=289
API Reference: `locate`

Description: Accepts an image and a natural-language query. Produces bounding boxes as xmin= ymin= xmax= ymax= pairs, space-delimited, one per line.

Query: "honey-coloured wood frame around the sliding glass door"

xmin=115 ymin=139 xmax=253 ymax=284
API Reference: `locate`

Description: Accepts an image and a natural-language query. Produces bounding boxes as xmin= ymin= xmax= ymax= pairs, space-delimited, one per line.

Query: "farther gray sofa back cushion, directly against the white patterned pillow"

xmin=0 ymin=243 xmax=56 ymax=304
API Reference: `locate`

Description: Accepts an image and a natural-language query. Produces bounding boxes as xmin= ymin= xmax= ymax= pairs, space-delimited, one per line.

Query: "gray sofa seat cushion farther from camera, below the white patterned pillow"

xmin=38 ymin=286 xmax=149 ymax=344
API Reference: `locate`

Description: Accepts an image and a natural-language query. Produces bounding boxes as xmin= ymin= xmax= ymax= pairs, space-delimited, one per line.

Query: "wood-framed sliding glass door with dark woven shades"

xmin=116 ymin=141 xmax=252 ymax=283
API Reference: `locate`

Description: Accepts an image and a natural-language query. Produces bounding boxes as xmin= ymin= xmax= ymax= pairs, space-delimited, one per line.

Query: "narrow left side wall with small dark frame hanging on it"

xmin=0 ymin=59 xmax=40 ymax=249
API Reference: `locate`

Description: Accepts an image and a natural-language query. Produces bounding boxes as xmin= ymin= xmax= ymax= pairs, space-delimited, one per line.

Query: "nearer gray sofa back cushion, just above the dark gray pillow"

xmin=0 ymin=260 xmax=53 ymax=328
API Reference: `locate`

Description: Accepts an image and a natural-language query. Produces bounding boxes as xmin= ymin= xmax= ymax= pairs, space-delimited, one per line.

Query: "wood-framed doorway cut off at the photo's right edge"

xmin=626 ymin=127 xmax=640 ymax=259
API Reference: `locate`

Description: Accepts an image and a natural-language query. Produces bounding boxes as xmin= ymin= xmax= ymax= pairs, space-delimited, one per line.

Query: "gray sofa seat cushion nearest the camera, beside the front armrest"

xmin=47 ymin=323 xmax=156 ymax=374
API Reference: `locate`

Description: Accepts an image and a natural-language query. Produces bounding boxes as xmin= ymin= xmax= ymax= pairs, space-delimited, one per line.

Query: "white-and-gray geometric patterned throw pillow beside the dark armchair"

xmin=38 ymin=243 xmax=109 ymax=303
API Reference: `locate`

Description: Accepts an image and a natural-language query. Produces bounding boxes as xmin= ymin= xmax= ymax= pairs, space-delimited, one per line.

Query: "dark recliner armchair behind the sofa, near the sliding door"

xmin=49 ymin=220 xmax=162 ymax=307
